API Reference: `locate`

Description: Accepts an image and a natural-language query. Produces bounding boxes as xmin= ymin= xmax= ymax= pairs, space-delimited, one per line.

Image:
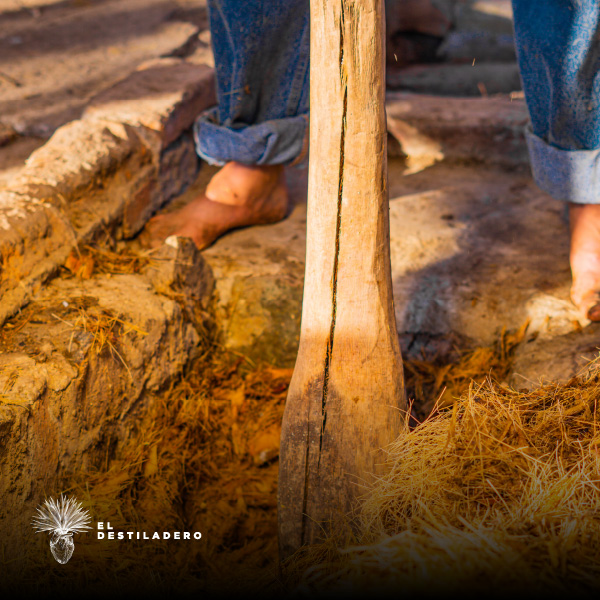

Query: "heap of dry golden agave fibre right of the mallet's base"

xmin=288 ymin=364 xmax=600 ymax=594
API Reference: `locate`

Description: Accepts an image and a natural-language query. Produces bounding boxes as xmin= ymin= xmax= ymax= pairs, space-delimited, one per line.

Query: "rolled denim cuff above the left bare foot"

xmin=194 ymin=108 xmax=308 ymax=165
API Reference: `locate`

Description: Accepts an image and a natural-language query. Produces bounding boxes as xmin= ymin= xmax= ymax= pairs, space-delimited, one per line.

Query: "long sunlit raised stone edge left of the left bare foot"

xmin=0 ymin=58 xmax=216 ymax=326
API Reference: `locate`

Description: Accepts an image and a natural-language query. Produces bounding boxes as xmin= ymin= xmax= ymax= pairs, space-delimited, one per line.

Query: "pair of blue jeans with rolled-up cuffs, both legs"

xmin=199 ymin=0 xmax=600 ymax=204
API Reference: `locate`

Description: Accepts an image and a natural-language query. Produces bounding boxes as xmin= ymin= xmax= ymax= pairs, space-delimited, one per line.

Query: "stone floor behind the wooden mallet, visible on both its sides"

xmin=184 ymin=159 xmax=598 ymax=387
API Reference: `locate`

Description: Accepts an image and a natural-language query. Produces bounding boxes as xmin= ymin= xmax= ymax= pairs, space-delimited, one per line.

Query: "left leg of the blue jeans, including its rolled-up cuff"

xmin=194 ymin=0 xmax=309 ymax=165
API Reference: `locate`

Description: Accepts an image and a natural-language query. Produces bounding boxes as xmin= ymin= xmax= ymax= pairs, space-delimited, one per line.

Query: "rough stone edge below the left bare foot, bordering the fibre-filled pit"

xmin=0 ymin=238 xmax=214 ymax=560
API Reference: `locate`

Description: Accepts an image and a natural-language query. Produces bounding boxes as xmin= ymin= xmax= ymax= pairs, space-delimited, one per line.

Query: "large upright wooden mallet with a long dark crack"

xmin=278 ymin=0 xmax=406 ymax=559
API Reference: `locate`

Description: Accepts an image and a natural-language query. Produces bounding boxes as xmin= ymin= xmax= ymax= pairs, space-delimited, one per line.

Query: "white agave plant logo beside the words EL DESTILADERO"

xmin=32 ymin=495 xmax=91 ymax=565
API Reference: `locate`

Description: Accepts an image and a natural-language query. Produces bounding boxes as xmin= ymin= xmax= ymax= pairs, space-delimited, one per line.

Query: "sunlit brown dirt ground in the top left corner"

xmin=0 ymin=0 xmax=212 ymax=188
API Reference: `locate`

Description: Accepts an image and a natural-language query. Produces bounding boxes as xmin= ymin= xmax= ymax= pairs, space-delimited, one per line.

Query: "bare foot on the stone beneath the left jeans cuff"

xmin=142 ymin=162 xmax=288 ymax=250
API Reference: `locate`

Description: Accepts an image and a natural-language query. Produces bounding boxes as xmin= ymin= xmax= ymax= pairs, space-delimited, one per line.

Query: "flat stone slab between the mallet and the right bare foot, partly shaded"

xmin=389 ymin=164 xmax=588 ymax=346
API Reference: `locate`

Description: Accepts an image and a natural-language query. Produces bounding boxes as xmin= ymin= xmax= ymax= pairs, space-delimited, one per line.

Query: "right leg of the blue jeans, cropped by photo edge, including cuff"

xmin=512 ymin=0 xmax=600 ymax=204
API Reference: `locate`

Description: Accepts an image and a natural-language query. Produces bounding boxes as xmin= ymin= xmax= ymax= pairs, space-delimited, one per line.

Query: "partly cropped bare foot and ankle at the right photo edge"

xmin=569 ymin=204 xmax=600 ymax=321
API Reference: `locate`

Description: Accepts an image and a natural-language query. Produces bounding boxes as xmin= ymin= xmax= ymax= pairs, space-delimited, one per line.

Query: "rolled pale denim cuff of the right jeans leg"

xmin=525 ymin=127 xmax=600 ymax=204
